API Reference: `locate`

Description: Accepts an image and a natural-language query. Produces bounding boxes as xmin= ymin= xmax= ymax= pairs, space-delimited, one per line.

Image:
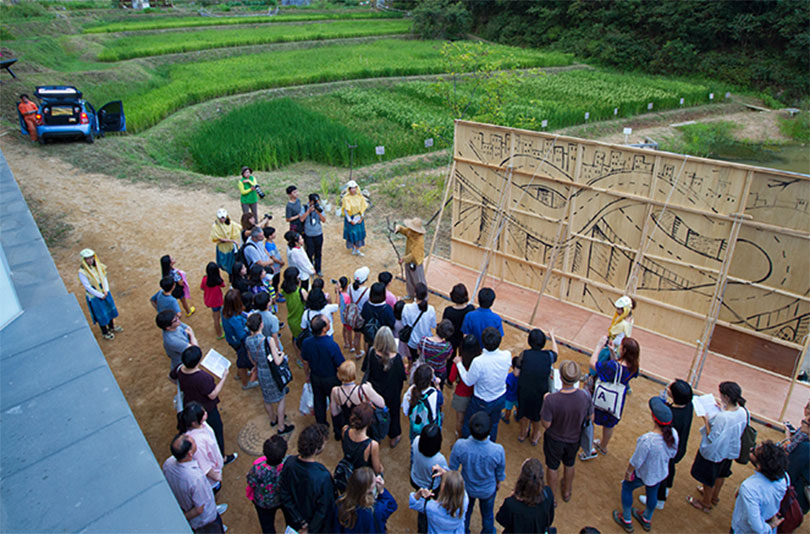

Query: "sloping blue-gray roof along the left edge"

xmin=0 ymin=152 xmax=190 ymax=532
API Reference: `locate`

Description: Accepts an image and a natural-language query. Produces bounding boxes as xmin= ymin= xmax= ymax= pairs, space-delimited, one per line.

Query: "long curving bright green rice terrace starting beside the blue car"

xmin=94 ymin=39 xmax=573 ymax=132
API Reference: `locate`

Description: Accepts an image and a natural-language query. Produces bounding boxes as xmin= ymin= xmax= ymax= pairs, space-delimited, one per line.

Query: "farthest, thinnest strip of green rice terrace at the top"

xmin=84 ymin=11 xmax=401 ymax=33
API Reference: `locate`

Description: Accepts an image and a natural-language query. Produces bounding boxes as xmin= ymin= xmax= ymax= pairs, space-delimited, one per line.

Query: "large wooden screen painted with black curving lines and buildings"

xmin=451 ymin=121 xmax=810 ymax=374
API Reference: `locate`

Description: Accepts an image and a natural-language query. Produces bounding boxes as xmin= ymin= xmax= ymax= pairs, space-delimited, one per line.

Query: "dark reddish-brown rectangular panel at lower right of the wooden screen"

xmin=709 ymin=325 xmax=799 ymax=377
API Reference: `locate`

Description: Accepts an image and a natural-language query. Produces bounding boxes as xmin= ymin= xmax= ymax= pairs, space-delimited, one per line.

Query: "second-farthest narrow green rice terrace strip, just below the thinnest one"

xmin=98 ymin=19 xmax=411 ymax=61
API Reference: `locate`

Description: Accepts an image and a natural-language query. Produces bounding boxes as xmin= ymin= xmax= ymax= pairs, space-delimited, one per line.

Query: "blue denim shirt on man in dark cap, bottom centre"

xmin=450 ymin=438 xmax=506 ymax=499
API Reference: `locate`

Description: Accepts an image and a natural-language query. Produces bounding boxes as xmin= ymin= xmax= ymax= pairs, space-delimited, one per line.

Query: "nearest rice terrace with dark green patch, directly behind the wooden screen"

xmin=185 ymin=70 xmax=722 ymax=175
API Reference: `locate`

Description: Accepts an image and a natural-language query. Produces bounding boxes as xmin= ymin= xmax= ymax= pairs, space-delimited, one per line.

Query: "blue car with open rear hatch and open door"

xmin=17 ymin=85 xmax=127 ymax=144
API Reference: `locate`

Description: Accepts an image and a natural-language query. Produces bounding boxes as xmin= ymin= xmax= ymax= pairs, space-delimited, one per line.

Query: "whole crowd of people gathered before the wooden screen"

xmin=79 ymin=174 xmax=810 ymax=533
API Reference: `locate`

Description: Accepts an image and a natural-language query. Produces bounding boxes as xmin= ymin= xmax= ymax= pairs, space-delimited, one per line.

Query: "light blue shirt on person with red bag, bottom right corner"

xmin=731 ymin=471 xmax=787 ymax=534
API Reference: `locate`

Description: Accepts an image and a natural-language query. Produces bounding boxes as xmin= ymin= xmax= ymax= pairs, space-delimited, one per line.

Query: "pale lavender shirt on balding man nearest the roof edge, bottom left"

xmin=163 ymin=456 xmax=217 ymax=530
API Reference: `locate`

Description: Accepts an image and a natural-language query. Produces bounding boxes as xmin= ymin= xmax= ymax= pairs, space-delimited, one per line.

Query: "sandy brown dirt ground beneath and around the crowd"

xmin=0 ymin=121 xmax=779 ymax=532
